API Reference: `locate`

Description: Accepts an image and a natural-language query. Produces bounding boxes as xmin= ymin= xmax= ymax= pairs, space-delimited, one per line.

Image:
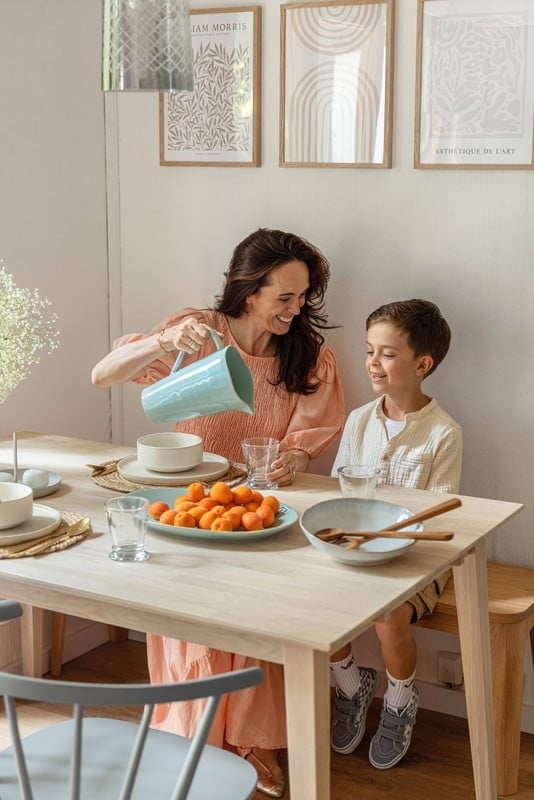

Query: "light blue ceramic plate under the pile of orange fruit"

xmin=129 ymin=489 xmax=298 ymax=542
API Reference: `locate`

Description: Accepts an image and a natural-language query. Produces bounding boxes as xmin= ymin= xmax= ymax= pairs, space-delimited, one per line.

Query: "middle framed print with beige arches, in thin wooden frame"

xmin=279 ymin=0 xmax=395 ymax=168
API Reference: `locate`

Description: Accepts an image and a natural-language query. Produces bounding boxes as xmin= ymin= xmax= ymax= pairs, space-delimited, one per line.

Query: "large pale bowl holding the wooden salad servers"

xmin=299 ymin=497 xmax=423 ymax=567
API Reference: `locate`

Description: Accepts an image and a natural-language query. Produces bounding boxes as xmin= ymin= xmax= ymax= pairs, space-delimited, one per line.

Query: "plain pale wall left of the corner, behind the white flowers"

xmin=0 ymin=0 xmax=109 ymax=440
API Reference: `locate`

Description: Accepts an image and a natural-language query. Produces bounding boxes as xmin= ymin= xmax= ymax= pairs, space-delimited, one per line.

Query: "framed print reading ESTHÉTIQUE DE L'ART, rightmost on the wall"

xmin=414 ymin=0 xmax=534 ymax=169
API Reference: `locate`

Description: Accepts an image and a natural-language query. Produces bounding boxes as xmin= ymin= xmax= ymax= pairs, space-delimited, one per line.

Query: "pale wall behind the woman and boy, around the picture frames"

xmin=112 ymin=0 xmax=534 ymax=729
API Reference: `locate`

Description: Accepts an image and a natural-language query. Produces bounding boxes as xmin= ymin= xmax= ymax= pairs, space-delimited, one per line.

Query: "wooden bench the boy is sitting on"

xmin=417 ymin=562 xmax=534 ymax=796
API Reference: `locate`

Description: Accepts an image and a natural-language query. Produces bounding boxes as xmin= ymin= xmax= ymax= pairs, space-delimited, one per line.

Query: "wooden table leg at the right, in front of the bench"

xmin=453 ymin=542 xmax=497 ymax=800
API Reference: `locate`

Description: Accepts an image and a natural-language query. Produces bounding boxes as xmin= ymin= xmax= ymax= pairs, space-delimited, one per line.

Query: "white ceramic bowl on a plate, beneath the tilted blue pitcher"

xmin=137 ymin=432 xmax=204 ymax=472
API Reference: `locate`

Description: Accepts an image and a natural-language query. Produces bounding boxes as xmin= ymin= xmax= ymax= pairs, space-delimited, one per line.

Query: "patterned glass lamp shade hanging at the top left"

xmin=102 ymin=0 xmax=193 ymax=92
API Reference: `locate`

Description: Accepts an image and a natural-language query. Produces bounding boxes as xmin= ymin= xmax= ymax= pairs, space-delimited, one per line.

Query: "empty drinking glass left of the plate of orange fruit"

xmin=105 ymin=496 xmax=149 ymax=561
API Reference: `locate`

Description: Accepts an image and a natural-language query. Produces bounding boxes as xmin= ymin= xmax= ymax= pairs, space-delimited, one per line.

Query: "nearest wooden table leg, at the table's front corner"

xmin=284 ymin=646 xmax=330 ymax=800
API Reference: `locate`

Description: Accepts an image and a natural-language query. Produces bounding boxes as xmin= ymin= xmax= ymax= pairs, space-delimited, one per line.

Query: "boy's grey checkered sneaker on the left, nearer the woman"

xmin=330 ymin=667 xmax=378 ymax=755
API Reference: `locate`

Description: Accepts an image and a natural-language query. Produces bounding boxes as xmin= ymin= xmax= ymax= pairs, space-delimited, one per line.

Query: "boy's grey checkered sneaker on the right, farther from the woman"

xmin=369 ymin=686 xmax=419 ymax=769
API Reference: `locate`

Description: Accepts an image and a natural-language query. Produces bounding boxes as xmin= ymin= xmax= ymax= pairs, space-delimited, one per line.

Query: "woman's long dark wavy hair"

xmin=215 ymin=228 xmax=330 ymax=394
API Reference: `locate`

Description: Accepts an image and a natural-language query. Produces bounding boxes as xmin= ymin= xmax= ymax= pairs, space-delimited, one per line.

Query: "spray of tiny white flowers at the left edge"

xmin=0 ymin=259 xmax=59 ymax=403
